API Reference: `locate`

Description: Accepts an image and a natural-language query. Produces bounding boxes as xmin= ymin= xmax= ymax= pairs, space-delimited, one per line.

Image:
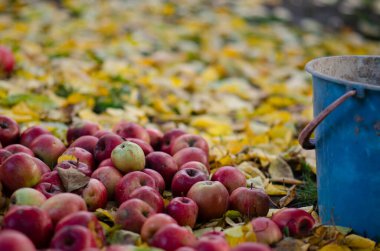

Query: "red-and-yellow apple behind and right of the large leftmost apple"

xmin=30 ymin=134 xmax=66 ymax=167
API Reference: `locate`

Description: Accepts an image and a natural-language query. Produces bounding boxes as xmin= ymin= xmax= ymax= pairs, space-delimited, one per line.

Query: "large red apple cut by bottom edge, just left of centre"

xmin=151 ymin=224 xmax=197 ymax=251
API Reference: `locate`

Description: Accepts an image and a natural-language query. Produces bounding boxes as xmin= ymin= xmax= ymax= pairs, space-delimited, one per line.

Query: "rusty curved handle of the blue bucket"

xmin=298 ymin=90 xmax=357 ymax=150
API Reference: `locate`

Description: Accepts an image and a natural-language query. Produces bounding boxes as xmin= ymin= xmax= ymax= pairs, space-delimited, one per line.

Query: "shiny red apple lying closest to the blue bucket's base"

xmin=272 ymin=208 xmax=315 ymax=237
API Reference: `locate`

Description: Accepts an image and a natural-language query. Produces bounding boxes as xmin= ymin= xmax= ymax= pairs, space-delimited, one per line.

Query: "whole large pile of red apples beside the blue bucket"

xmin=0 ymin=116 xmax=314 ymax=251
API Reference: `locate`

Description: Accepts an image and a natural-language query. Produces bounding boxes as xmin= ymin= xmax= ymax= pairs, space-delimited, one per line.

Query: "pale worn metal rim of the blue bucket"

xmin=305 ymin=55 xmax=380 ymax=91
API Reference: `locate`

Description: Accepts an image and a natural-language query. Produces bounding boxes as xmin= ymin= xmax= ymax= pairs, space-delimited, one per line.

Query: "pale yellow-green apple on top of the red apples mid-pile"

xmin=111 ymin=141 xmax=145 ymax=173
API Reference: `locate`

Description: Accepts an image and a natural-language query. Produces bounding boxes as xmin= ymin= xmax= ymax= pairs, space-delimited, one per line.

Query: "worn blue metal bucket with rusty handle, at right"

xmin=299 ymin=56 xmax=380 ymax=241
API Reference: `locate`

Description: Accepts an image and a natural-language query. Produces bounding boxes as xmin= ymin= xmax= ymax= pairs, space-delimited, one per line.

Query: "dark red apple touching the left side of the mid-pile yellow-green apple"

xmin=94 ymin=133 xmax=124 ymax=163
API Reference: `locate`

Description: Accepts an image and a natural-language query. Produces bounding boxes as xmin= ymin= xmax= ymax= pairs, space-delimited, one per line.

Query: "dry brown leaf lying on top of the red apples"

xmin=57 ymin=167 xmax=90 ymax=192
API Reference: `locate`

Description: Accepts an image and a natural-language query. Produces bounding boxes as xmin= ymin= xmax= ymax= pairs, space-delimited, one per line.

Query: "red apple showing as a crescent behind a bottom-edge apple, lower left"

xmin=55 ymin=211 xmax=105 ymax=247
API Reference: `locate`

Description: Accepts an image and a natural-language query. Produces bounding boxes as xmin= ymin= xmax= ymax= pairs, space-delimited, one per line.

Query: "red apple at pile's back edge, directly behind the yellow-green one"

xmin=113 ymin=121 xmax=150 ymax=144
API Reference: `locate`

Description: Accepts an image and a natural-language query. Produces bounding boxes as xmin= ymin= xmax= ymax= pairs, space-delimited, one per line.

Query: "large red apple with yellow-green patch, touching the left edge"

xmin=0 ymin=153 xmax=42 ymax=192
